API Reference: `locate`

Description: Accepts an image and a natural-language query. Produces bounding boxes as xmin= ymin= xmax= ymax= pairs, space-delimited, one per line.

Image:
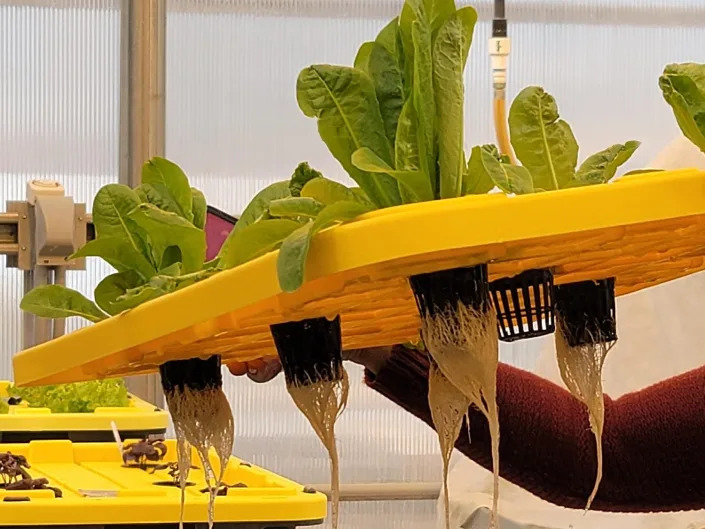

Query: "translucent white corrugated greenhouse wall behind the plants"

xmin=0 ymin=0 xmax=705 ymax=529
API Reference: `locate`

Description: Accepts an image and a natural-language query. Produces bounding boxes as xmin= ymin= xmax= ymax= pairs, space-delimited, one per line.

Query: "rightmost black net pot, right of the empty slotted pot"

xmin=553 ymin=278 xmax=617 ymax=347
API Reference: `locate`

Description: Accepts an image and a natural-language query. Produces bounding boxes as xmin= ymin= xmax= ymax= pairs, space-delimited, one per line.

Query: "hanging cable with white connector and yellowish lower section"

xmin=490 ymin=0 xmax=515 ymax=163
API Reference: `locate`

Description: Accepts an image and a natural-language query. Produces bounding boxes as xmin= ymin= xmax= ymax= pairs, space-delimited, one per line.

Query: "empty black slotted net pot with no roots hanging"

xmin=490 ymin=270 xmax=556 ymax=342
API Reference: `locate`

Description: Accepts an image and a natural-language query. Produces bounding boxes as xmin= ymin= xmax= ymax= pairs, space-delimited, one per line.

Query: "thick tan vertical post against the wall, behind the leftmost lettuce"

xmin=119 ymin=0 xmax=166 ymax=406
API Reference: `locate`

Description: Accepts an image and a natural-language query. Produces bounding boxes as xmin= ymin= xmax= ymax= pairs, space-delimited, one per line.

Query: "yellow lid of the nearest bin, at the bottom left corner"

xmin=0 ymin=440 xmax=327 ymax=528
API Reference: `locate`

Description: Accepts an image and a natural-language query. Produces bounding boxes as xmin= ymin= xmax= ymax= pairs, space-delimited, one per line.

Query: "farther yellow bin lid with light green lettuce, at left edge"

xmin=0 ymin=381 xmax=169 ymax=436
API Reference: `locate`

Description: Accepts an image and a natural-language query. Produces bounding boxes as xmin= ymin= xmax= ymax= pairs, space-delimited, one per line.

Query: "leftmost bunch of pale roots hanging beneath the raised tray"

xmin=165 ymin=387 xmax=234 ymax=529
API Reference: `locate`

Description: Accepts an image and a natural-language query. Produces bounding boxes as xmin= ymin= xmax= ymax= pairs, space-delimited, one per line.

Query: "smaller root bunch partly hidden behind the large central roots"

xmin=428 ymin=359 xmax=470 ymax=529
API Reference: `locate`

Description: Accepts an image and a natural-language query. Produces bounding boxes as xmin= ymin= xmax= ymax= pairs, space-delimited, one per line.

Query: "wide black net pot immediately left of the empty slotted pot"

xmin=409 ymin=264 xmax=490 ymax=317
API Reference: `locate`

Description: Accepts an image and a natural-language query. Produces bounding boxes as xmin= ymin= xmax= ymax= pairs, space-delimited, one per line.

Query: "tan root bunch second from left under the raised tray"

xmin=287 ymin=366 xmax=350 ymax=529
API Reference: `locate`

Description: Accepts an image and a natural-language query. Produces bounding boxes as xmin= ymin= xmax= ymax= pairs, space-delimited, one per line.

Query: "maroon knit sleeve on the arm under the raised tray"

xmin=367 ymin=347 xmax=705 ymax=512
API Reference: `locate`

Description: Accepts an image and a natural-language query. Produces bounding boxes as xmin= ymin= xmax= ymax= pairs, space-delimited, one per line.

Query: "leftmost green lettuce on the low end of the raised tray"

xmin=20 ymin=158 xmax=216 ymax=323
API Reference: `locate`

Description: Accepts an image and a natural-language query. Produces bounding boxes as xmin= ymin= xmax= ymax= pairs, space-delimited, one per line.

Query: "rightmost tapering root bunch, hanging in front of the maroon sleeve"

xmin=556 ymin=315 xmax=615 ymax=512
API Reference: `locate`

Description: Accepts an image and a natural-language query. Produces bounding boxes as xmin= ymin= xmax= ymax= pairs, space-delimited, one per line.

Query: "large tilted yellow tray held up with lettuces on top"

xmin=14 ymin=169 xmax=705 ymax=384
